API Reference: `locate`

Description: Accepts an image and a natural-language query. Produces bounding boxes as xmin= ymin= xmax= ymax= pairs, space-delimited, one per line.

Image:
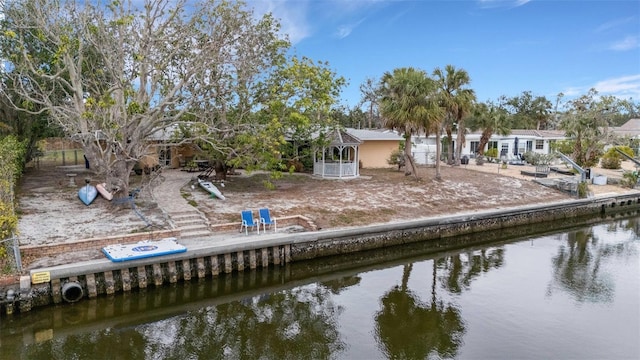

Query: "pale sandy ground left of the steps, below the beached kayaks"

xmin=17 ymin=166 xmax=169 ymax=245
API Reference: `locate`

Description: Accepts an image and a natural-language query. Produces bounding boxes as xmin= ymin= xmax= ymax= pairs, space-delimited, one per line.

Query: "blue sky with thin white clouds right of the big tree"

xmin=248 ymin=0 xmax=640 ymax=107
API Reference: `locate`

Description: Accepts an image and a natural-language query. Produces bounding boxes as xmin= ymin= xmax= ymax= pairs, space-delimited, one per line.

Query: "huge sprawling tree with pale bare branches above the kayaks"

xmin=3 ymin=0 xmax=289 ymax=194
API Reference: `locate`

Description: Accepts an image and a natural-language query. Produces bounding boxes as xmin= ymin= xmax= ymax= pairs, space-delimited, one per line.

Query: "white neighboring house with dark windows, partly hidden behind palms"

xmin=412 ymin=129 xmax=567 ymax=164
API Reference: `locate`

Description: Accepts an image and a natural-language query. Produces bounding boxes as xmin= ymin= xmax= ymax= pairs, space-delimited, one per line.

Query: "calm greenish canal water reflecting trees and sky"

xmin=0 ymin=215 xmax=640 ymax=360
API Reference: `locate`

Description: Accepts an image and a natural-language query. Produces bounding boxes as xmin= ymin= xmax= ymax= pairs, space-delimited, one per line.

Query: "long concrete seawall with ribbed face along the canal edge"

xmin=1 ymin=193 xmax=640 ymax=313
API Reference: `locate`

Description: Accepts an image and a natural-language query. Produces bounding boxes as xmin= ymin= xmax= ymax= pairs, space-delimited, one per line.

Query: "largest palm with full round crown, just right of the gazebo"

xmin=380 ymin=67 xmax=440 ymax=178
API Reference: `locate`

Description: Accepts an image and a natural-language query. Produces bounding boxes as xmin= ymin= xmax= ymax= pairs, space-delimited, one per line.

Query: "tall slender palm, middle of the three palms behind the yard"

xmin=433 ymin=65 xmax=476 ymax=165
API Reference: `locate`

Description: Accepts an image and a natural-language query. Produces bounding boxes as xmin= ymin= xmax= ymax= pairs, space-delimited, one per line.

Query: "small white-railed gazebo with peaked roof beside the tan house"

xmin=313 ymin=130 xmax=362 ymax=179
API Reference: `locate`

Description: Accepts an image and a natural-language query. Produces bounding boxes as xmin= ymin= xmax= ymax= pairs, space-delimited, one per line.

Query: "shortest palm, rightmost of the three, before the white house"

xmin=468 ymin=102 xmax=511 ymax=155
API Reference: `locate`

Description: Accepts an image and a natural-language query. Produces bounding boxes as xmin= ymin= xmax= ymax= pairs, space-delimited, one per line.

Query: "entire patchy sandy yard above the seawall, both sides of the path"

xmin=18 ymin=161 xmax=635 ymax=249
